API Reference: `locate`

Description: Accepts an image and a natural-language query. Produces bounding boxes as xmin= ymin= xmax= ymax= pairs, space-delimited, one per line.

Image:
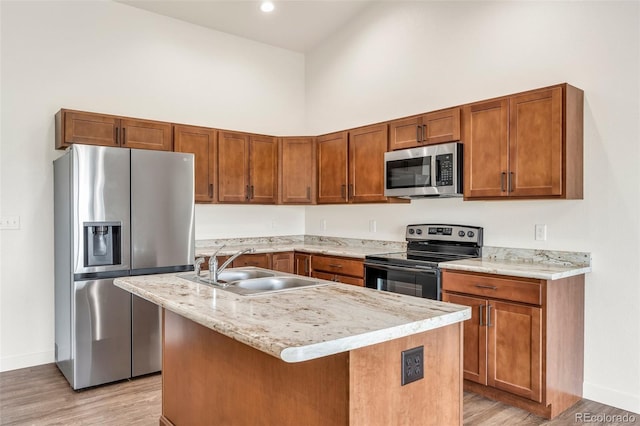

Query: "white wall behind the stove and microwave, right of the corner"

xmin=306 ymin=2 xmax=640 ymax=412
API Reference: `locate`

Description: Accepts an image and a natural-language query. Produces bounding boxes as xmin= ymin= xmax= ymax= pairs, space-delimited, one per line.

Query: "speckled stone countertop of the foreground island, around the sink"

xmin=115 ymin=273 xmax=471 ymax=362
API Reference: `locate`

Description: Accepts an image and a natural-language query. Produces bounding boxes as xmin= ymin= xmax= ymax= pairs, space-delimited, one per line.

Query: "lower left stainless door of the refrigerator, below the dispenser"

xmin=70 ymin=279 xmax=131 ymax=389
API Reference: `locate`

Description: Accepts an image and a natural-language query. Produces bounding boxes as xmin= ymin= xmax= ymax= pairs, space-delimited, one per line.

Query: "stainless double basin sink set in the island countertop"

xmin=178 ymin=267 xmax=327 ymax=296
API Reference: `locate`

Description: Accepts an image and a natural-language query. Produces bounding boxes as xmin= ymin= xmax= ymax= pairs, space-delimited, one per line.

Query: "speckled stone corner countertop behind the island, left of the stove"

xmin=196 ymin=235 xmax=407 ymax=259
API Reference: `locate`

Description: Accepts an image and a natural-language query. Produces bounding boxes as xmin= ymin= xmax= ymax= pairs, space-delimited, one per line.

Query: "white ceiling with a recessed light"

xmin=114 ymin=0 xmax=371 ymax=53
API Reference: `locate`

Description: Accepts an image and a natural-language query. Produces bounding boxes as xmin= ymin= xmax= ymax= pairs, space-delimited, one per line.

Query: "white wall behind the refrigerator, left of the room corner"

xmin=0 ymin=0 xmax=304 ymax=370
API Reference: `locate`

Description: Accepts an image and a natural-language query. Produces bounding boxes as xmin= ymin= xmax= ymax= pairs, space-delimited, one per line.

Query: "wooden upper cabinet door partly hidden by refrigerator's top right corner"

xmin=173 ymin=126 xmax=217 ymax=203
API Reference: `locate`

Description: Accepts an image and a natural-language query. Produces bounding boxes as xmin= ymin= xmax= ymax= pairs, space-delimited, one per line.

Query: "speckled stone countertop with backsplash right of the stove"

xmin=439 ymin=247 xmax=591 ymax=280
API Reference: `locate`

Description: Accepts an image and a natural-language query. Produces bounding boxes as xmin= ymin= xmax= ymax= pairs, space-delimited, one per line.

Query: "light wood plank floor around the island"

xmin=0 ymin=364 xmax=640 ymax=426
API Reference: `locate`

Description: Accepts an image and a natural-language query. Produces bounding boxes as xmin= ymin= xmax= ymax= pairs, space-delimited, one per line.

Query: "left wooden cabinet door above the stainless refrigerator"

xmin=62 ymin=110 xmax=120 ymax=148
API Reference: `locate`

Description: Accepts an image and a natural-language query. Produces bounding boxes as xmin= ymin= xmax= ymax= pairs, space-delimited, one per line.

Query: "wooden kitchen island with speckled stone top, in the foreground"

xmin=115 ymin=268 xmax=471 ymax=425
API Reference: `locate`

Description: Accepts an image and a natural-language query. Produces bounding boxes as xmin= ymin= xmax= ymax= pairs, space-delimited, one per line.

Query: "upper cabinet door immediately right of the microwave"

xmin=462 ymin=98 xmax=509 ymax=198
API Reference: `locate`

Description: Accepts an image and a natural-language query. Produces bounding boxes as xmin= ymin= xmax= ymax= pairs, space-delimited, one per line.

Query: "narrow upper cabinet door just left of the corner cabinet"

xmin=249 ymin=135 xmax=278 ymax=204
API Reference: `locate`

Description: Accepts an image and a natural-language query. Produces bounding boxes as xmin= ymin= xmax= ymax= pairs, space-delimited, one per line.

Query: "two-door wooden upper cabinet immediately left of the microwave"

xmin=317 ymin=124 xmax=388 ymax=204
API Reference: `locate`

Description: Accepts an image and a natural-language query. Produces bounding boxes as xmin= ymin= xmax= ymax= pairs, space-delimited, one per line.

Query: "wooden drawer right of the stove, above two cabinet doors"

xmin=442 ymin=270 xmax=542 ymax=305
